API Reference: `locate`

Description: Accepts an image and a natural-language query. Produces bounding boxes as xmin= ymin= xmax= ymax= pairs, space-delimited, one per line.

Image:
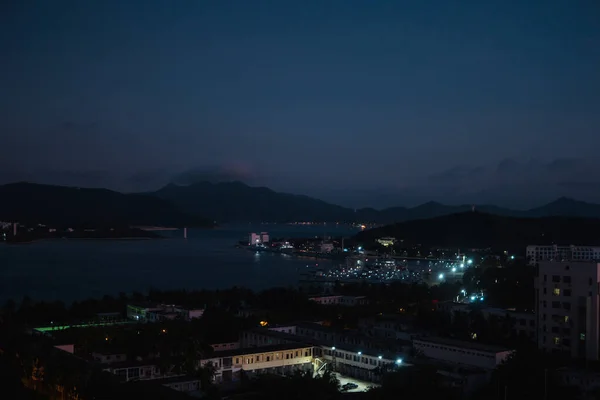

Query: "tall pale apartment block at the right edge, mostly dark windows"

xmin=535 ymin=261 xmax=600 ymax=360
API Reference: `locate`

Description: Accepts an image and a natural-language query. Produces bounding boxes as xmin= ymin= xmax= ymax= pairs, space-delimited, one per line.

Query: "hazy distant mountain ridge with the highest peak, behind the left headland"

xmin=149 ymin=182 xmax=600 ymax=224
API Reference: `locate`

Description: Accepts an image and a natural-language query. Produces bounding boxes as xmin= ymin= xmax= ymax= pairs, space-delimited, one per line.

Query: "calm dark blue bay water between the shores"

xmin=0 ymin=225 xmax=357 ymax=302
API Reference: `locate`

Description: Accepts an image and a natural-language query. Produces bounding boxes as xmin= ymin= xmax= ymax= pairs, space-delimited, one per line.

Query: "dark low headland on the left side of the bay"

xmin=0 ymin=183 xmax=212 ymax=227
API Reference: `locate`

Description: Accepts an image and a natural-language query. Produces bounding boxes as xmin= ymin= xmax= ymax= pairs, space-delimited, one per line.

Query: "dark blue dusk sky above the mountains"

xmin=0 ymin=0 xmax=600 ymax=207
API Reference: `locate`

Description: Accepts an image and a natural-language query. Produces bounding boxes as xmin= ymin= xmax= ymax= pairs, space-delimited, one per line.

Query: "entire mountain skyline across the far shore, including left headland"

xmin=0 ymin=182 xmax=600 ymax=227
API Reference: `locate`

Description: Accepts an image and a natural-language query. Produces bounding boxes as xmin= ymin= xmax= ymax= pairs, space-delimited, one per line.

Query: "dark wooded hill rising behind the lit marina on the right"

xmin=356 ymin=212 xmax=600 ymax=252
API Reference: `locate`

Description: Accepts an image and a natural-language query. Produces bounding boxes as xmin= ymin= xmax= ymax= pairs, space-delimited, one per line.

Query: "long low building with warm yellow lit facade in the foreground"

xmin=200 ymin=343 xmax=314 ymax=383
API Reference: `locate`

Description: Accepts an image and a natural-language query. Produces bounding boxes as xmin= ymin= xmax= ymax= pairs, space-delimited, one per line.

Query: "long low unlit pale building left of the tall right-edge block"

xmin=413 ymin=337 xmax=513 ymax=370
